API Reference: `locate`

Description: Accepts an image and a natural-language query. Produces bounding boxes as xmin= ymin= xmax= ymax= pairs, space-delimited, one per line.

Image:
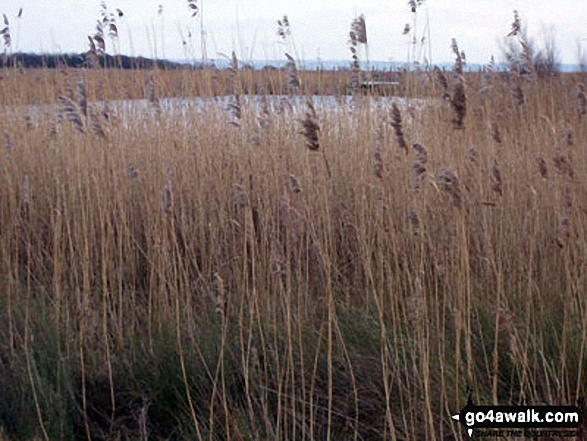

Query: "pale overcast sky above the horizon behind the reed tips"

xmin=0 ymin=0 xmax=587 ymax=63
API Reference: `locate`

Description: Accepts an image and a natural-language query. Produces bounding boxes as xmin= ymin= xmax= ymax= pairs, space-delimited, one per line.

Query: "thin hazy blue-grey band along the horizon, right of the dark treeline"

xmin=170 ymin=58 xmax=581 ymax=72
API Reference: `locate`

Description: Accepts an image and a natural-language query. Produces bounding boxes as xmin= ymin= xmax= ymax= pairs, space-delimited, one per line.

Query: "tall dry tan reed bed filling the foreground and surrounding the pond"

xmin=0 ymin=56 xmax=587 ymax=440
